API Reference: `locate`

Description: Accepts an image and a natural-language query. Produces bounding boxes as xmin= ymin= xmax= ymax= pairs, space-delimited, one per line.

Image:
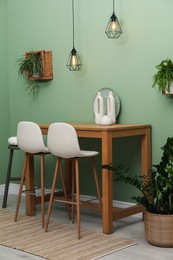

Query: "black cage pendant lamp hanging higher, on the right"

xmin=105 ymin=0 xmax=122 ymax=39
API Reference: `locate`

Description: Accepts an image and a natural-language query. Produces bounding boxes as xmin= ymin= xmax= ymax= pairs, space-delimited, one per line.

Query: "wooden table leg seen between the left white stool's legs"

xmin=25 ymin=155 xmax=35 ymax=216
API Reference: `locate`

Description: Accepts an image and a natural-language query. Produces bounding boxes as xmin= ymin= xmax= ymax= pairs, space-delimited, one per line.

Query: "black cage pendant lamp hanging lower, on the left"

xmin=67 ymin=0 xmax=82 ymax=71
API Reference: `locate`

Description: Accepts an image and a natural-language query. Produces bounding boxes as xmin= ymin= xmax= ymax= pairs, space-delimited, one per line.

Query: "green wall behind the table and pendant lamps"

xmin=0 ymin=0 xmax=173 ymax=200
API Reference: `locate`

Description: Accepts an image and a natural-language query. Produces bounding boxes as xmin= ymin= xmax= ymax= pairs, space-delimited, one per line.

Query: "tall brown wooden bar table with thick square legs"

xmin=26 ymin=123 xmax=151 ymax=234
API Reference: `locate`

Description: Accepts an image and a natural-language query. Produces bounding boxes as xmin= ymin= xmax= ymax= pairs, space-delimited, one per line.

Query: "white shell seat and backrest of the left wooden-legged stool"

xmin=17 ymin=121 xmax=48 ymax=154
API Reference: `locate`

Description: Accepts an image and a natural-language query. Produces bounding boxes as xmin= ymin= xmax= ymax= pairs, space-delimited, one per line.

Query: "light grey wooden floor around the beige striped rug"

xmin=0 ymin=195 xmax=173 ymax=260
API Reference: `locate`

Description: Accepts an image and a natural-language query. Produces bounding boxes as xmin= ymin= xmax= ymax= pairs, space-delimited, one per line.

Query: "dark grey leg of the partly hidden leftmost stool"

xmin=2 ymin=149 xmax=14 ymax=208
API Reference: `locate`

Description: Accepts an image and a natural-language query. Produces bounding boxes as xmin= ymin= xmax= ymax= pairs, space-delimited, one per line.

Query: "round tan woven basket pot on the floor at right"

xmin=144 ymin=211 xmax=173 ymax=247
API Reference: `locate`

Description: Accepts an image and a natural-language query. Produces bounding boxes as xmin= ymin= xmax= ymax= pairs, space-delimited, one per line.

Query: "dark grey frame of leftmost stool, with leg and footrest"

xmin=2 ymin=143 xmax=21 ymax=208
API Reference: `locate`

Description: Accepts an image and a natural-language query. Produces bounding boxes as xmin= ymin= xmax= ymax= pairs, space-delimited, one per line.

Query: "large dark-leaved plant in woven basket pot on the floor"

xmin=102 ymin=137 xmax=173 ymax=247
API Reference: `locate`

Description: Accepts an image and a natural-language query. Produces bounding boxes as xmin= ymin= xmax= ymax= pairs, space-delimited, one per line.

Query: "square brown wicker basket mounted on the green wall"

xmin=25 ymin=50 xmax=53 ymax=81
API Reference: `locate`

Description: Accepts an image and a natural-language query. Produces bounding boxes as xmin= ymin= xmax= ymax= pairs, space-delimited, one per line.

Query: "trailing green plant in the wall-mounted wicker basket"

xmin=17 ymin=51 xmax=42 ymax=95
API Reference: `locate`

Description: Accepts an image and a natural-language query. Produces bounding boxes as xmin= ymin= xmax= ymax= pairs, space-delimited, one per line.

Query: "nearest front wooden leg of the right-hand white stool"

xmin=75 ymin=159 xmax=80 ymax=239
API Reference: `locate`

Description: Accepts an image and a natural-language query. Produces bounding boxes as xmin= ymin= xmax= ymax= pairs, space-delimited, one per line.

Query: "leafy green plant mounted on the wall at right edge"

xmin=152 ymin=59 xmax=173 ymax=94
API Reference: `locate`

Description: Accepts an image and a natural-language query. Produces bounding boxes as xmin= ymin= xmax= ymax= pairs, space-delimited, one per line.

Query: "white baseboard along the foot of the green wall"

xmin=0 ymin=183 xmax=142 ymax=218
